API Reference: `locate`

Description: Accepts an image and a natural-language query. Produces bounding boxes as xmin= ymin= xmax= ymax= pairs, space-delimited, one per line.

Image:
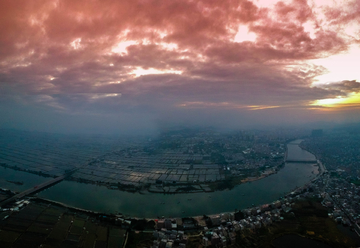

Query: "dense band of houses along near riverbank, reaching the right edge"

xmin=148 ymin=165 xmax=360 ymax=248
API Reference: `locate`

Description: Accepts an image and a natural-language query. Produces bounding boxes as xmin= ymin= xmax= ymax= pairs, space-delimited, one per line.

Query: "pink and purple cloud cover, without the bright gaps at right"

xmin=0 ymin=0 xmax=360 ymax=132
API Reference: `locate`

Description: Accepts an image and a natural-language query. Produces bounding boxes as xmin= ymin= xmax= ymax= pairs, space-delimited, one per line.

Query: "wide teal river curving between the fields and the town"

xmin=1 ymin=140 xmax=318 ymax=218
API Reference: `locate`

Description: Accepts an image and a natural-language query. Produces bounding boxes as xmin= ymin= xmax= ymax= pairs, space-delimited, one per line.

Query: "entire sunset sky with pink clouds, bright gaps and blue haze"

xmin=0 ymin=0 xmax=360 ymax=133
